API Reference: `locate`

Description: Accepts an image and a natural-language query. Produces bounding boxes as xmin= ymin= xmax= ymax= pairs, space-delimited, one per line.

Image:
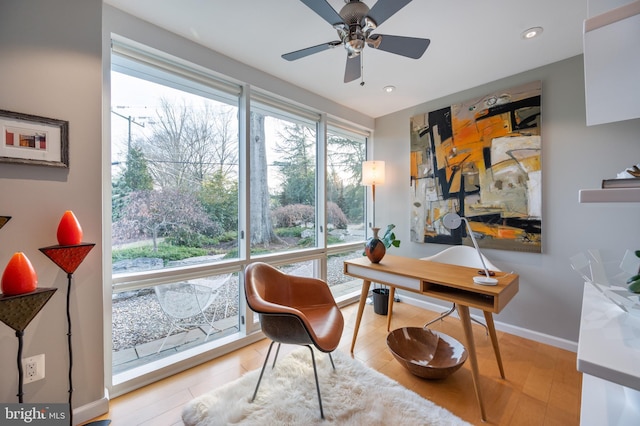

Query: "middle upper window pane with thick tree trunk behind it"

xmin=249 ymin=98 xmax=320 ymax=255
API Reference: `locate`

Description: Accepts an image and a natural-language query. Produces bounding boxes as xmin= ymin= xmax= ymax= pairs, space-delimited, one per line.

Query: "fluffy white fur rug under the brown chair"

xmin=182 ymin=347 xmax=469 ymax=426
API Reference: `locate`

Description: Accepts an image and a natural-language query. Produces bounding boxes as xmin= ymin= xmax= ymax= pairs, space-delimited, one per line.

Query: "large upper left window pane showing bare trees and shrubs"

xmin=111 ymin=59 xmax=238 ymax=274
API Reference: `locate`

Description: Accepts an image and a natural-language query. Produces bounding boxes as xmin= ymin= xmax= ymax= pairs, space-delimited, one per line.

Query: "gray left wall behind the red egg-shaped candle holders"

xmin=0 ymin=0 xmax=104 ymax=420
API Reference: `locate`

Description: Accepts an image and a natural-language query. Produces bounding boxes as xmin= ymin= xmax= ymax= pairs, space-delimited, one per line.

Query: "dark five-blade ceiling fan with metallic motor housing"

xmin=282 ymin=0 xmax=431 ymax=84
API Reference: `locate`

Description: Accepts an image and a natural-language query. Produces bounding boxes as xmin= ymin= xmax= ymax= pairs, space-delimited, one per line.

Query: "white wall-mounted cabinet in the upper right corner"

xmin=584 ymin=0 xmax=640 ymax=125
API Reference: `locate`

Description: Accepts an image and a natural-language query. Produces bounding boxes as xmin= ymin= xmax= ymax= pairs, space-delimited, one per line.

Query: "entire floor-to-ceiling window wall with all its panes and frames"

xmin=106 ymin=39 xmax=367 ymax=395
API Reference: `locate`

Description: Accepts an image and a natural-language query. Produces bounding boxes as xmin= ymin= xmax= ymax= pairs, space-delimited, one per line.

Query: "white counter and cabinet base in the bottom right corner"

xmin=578 ymin=283 xmax=640 ymax=426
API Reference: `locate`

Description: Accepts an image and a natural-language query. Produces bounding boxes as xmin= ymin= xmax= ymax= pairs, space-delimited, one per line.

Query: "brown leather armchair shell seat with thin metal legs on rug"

xmin=245 ymin=262 xmax=344 ymax=419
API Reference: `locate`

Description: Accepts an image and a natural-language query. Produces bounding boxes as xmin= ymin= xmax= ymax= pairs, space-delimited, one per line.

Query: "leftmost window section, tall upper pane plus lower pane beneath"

xmin=111 ymin=52 xmax=241 ymax=382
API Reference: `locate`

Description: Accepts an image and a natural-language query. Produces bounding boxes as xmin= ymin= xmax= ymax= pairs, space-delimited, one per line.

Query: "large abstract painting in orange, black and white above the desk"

xmin=410 ymin=81 xmax=542 ymax=253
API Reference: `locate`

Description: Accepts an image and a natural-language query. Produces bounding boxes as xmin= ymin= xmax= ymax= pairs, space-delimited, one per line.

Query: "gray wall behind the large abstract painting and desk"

xmin=374 ymin=56 xmax=640 ymax=347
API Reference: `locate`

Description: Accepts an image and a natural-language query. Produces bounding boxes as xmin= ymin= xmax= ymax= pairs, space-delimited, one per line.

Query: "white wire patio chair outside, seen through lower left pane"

xmin=154 ymin=274 xmax=231 ymax=353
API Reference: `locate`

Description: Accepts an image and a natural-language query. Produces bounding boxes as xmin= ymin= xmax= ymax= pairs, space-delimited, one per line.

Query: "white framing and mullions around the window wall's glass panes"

xmin=103 ymin=35 xmax=371 ymax=397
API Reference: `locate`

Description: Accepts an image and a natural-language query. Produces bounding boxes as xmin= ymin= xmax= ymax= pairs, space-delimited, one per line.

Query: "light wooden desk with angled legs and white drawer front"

xmin=344 ymin=254 xmax=518 ymax=421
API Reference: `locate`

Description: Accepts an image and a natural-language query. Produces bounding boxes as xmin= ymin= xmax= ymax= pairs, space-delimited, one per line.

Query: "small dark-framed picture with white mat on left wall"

xmin=0 ymin=110 xmax=69 ymax=168
